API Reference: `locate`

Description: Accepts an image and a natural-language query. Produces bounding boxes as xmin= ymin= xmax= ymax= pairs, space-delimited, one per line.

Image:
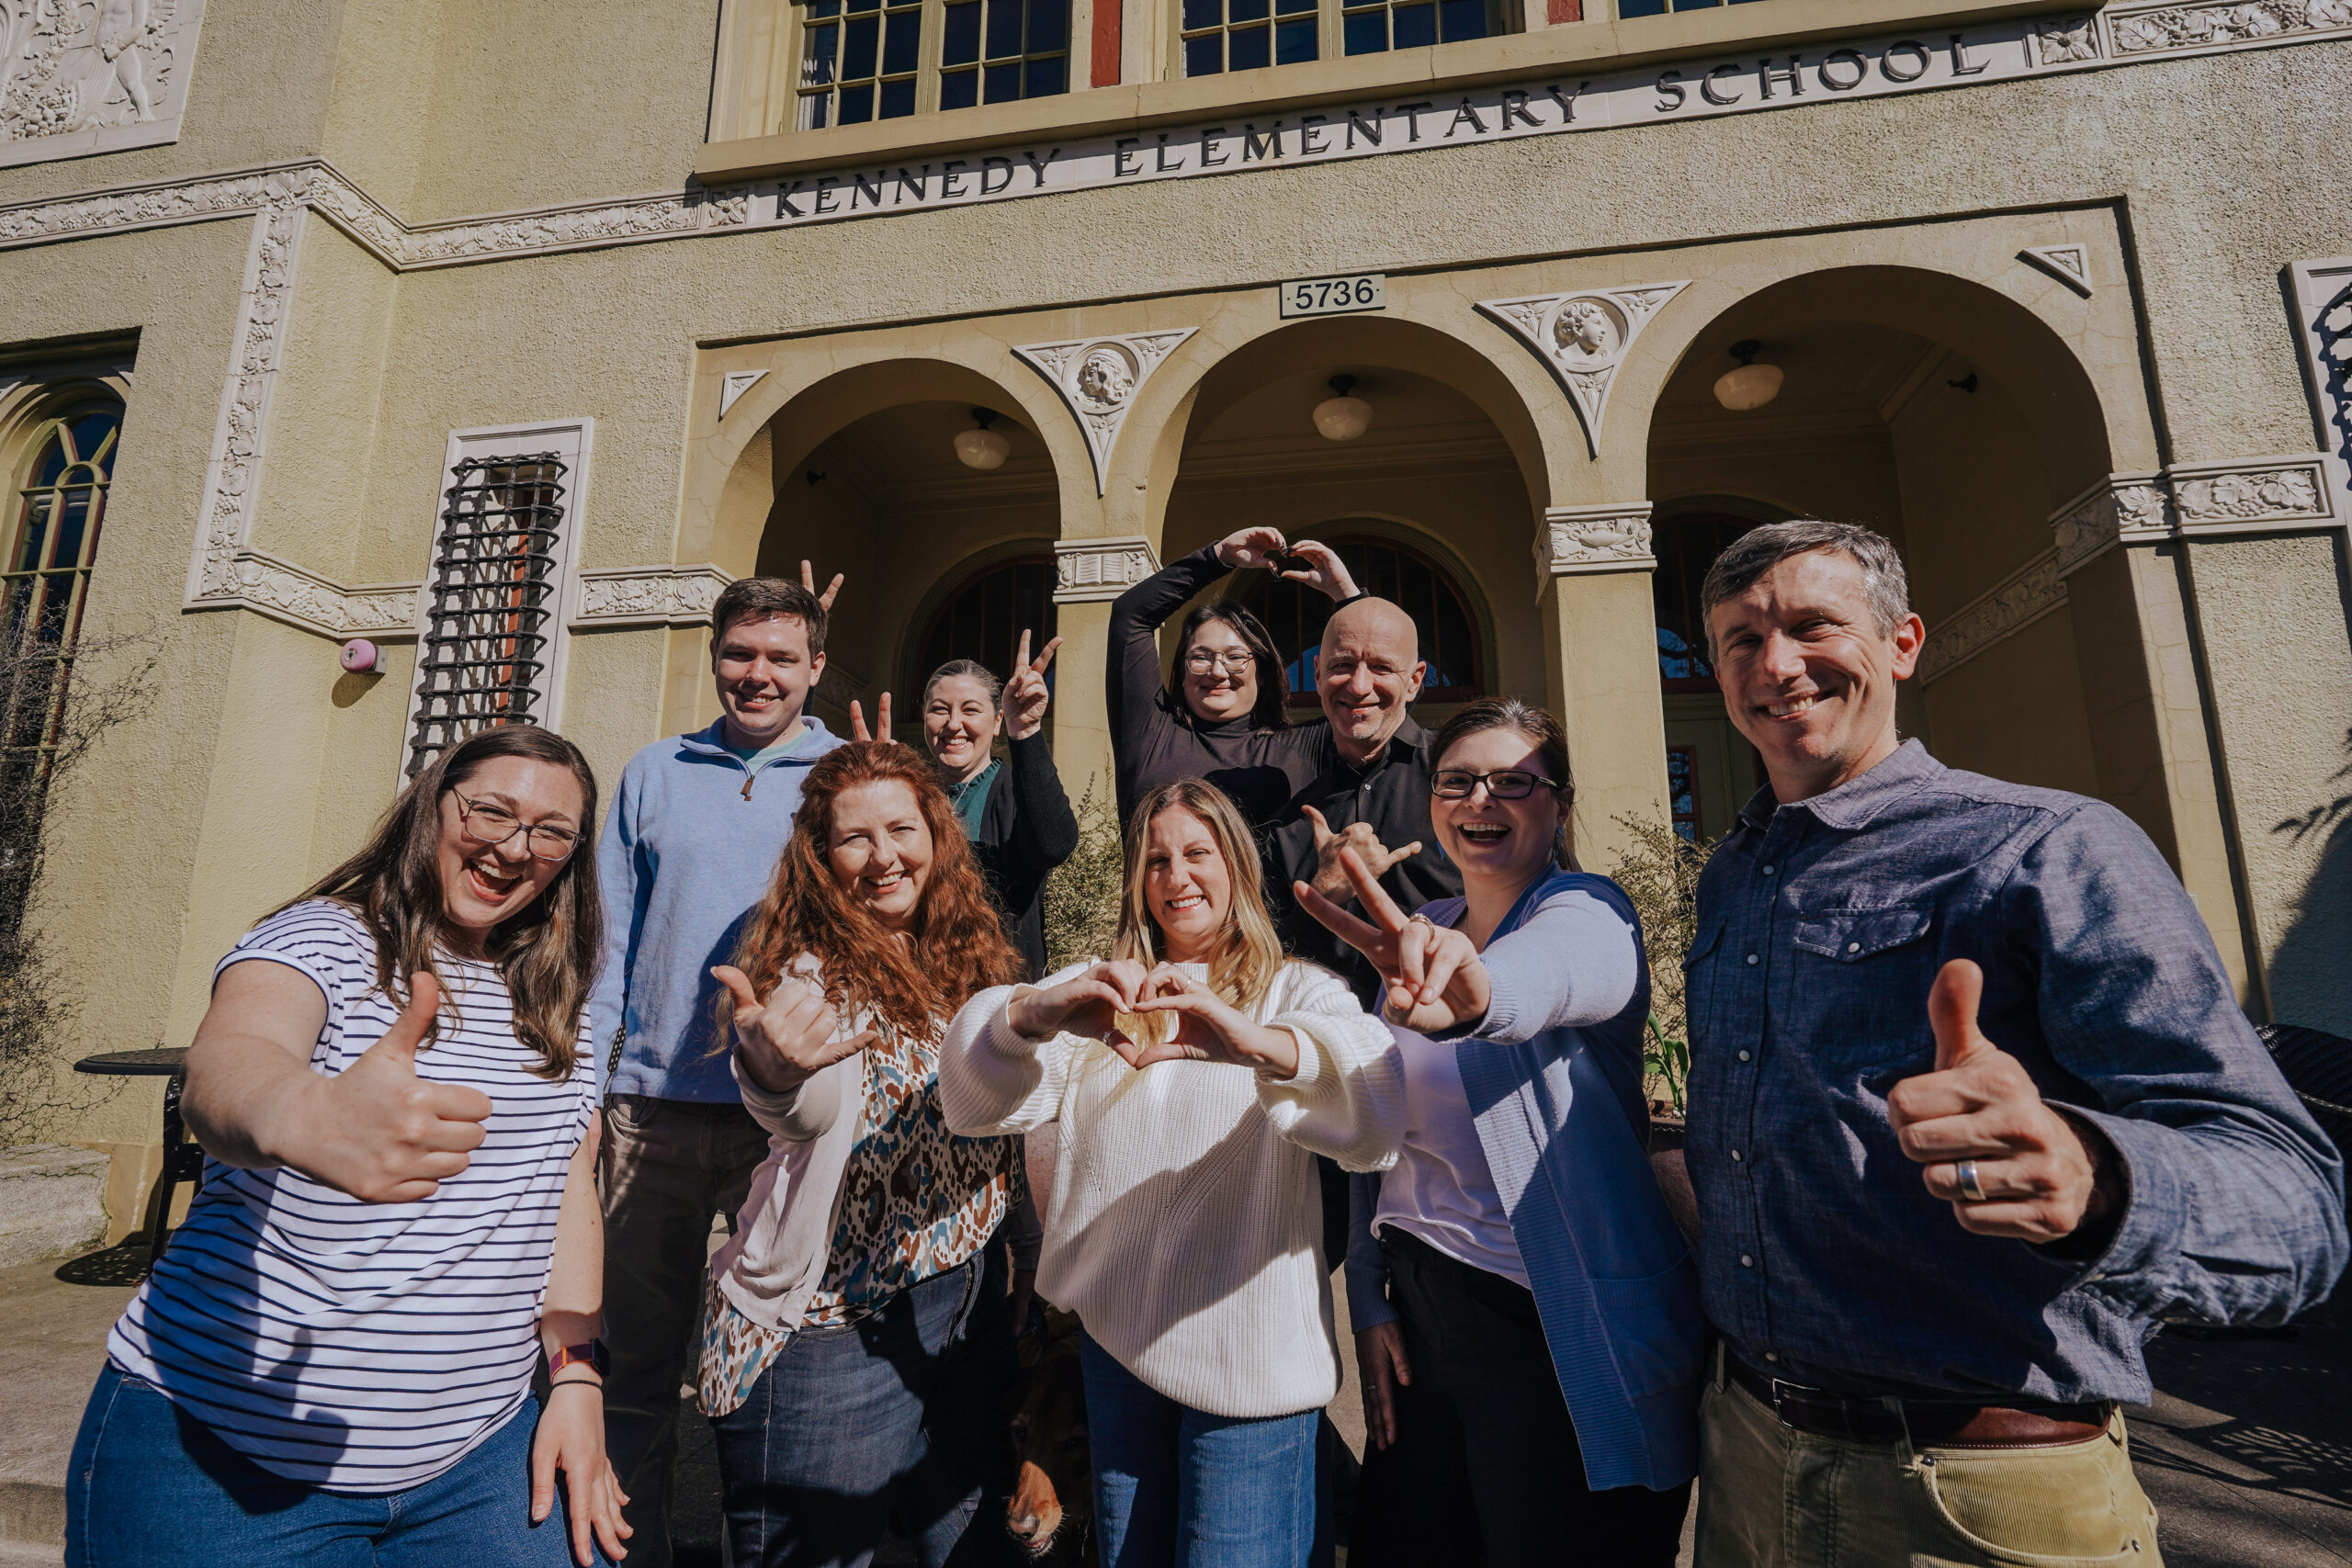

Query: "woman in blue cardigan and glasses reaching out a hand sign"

xmin=1294 ymin=698 xmax=1701 ymax=1568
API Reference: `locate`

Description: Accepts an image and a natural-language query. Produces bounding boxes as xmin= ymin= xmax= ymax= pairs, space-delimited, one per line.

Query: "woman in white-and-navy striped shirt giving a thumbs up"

xmin=66 ymin=727 xmax=628 ymax=1568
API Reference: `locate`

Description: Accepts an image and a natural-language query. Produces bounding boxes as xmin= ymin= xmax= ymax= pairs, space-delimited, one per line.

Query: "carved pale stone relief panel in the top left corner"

xmin=0 ymin=0 xmax=205 ymax=169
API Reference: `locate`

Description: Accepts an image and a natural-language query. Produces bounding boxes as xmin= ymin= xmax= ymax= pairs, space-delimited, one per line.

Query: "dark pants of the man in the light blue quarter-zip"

xmin=597 ymin=1096 xmax=767 ymax=1568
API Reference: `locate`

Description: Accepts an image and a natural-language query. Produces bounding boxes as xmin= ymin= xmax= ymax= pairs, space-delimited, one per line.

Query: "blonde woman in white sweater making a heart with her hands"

xmin=938 ymin=778 xmax=1404 ymax=1568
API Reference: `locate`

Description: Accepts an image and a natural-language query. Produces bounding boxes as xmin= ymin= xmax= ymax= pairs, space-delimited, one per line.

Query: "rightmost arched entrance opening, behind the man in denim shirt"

xmin=1649 ymin=268 xmax=2126 ymax=841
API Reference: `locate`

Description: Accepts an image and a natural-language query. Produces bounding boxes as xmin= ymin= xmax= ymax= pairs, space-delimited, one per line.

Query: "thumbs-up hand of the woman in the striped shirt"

xmin=315 ymin=971 xmax=492 ymax=1203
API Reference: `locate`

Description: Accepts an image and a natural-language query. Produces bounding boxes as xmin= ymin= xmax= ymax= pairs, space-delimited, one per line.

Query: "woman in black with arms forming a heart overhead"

xmin=1108 ymin=529 xmax=1362 ymax=856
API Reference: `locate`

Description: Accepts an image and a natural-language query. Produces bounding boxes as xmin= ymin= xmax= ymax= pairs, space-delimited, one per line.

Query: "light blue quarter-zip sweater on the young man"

xmin=588 ymin=717 xmax=842 ymax=1102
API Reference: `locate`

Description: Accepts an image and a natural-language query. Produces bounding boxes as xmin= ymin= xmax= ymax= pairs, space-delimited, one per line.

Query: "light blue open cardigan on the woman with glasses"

xmin=1348 ymin=872 xmax=1705 ymax=1491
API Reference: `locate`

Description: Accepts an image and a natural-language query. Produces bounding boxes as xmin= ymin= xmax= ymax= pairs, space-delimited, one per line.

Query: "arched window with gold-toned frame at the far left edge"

xmin=0 ymin=402 xmax=122 ymax=797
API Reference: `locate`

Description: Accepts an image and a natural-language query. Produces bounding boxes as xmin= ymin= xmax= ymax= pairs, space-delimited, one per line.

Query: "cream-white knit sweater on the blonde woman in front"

xmin=938 ymin=962 xmax=1404 ymax=1417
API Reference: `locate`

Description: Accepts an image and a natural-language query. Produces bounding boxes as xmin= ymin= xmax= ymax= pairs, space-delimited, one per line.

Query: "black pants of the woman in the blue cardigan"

xmin=1348 ymin=1227 xmax=1691 ymax=1568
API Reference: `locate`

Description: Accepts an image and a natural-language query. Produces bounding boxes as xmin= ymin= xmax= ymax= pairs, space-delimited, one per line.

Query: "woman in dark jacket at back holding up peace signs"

xmin=922 ymin=632 xmax=1077 ymax=978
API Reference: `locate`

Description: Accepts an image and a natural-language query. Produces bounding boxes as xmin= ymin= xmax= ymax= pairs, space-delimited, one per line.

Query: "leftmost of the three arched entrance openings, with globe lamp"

xmin=739 ymin=380 xmax=1061 ymax=740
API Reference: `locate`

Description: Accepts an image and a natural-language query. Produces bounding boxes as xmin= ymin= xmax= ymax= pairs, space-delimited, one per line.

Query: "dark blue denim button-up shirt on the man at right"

xmin=1687 ymin=740 xmax=2345 ymax=1404
